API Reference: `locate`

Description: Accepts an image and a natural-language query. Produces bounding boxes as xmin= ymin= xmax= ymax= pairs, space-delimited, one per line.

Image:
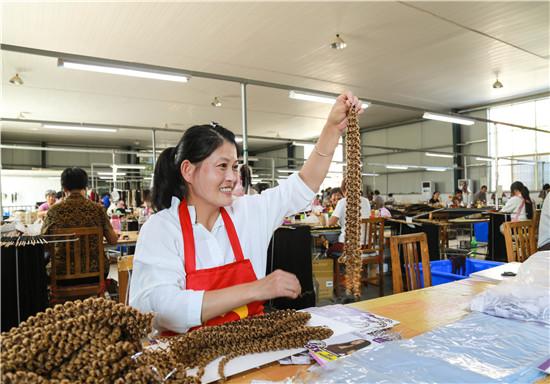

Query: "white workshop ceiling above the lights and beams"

xmin=1 ymin=1 xmax=550 ymax=150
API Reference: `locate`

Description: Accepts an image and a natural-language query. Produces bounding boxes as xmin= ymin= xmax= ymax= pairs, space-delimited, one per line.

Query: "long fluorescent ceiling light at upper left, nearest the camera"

xmin=57 ymin=59 xmax=190 ymax=83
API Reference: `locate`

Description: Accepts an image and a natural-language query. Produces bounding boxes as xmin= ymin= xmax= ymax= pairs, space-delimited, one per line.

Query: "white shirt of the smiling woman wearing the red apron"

xmin=130 ymin=173 xmax=315 ymax=333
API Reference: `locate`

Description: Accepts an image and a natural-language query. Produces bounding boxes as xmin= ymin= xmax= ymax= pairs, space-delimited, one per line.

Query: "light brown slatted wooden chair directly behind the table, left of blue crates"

xmin=390 ymin=232 xmax=432 ymax=293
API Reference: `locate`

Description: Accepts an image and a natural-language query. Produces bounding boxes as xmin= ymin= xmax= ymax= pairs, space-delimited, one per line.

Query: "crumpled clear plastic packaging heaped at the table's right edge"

xmin=470 ymin=251 xmax=550 ymax=325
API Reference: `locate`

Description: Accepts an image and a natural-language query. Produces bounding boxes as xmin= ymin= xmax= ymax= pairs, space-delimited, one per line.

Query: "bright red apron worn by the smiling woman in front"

xmin=178 ymin=199 xmax=264 ymax=329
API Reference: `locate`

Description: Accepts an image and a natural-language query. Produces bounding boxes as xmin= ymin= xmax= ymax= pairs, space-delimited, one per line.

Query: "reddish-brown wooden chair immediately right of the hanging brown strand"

xmin=361 ymin=217 xmax=385 ymax=297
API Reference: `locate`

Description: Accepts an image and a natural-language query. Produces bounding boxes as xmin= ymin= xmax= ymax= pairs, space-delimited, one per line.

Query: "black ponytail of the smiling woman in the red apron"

xmin=152 ymin=147 xmax=185 ymax=212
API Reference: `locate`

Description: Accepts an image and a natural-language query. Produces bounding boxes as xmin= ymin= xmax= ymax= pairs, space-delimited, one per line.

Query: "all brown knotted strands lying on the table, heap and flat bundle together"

xmin=1 ymin=304 xmax=332 ymax=384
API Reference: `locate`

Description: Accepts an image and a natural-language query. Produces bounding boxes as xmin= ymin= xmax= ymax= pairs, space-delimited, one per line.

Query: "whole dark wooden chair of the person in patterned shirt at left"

xmin=50 ymin=227 xmax=105 ymax=304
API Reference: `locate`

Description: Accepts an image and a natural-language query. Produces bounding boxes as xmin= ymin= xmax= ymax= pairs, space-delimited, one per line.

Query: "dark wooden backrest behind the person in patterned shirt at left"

xmin=51 ymin=227 xmax=104 ymax=287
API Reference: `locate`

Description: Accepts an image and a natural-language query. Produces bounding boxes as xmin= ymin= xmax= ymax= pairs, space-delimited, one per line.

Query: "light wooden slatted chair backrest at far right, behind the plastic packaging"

xmin=504 ymin=220 xmax=537 ymax=263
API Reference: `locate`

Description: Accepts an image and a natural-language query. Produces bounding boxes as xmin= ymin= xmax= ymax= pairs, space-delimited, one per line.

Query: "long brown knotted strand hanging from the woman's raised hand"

xmin=338 ymin=108 xmax=362 ymax=300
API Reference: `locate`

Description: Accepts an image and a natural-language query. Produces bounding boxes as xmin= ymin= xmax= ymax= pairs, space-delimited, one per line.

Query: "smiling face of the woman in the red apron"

xmin=184 ymin=140 xmax=239 ymax=208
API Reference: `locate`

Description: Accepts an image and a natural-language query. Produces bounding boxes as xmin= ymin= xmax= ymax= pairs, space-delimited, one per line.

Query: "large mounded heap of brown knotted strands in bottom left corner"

xmin=0 ymin=298 xmax=153 ymax=383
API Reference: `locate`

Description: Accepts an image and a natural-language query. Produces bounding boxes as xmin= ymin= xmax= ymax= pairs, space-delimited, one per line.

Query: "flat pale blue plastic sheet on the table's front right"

xmin=311 ymin=313 xmax=550 ymax=384
